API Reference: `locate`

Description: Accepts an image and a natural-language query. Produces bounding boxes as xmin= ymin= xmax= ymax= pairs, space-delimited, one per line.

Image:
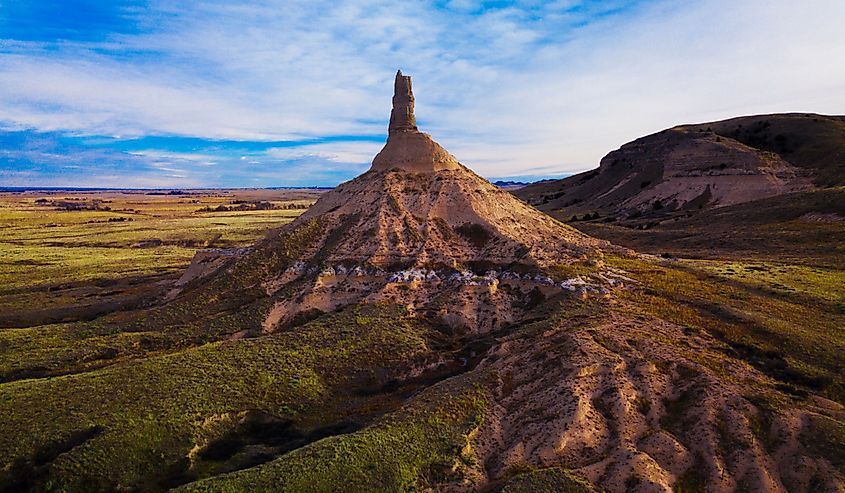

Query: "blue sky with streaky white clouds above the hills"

xmin=0 ymin=0 xmax=845 ymax=188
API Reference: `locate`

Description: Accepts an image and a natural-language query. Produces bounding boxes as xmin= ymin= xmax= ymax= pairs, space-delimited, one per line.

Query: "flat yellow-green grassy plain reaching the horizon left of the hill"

xmin=0 ymin=186 xmax=320 ymax=327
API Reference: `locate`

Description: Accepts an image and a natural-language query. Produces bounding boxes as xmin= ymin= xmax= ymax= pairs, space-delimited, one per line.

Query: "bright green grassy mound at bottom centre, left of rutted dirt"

xmin=178 ymin=379 xmax=487 ymax=493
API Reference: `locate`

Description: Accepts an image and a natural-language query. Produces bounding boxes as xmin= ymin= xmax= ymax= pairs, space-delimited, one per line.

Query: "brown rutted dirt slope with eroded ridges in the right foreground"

xmin=453 ymin=314 xmax=843 ymax=493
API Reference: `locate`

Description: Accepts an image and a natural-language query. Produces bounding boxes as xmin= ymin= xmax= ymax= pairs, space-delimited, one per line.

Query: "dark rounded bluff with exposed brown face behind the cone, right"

xmin=514 ymin=113 xmax=845 ymax=220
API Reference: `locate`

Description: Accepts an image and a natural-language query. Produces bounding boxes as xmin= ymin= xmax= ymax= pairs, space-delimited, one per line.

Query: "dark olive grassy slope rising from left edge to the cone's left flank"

xmin=0 ymin=221 xmax=322 ymax=381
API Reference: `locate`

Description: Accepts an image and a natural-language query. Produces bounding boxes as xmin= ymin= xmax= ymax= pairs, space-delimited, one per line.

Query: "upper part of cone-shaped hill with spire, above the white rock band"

xmin=286 ymin=72 xmax=601 ymax=269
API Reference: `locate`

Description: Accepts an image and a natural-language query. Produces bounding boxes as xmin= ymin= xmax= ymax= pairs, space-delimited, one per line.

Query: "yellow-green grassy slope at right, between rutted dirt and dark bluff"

xmin=607 ymin=257 xmax=845 ymax=402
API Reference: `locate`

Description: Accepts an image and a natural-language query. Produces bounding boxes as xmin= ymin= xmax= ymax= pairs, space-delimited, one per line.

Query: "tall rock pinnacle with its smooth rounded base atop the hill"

xmin=371 ymin=70 xmax=460 ymax=173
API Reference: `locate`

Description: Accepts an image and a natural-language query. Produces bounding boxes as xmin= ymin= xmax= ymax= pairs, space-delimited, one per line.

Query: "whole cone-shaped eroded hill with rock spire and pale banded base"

xmin=165 ymin=72 xmax=610 ymax=334
